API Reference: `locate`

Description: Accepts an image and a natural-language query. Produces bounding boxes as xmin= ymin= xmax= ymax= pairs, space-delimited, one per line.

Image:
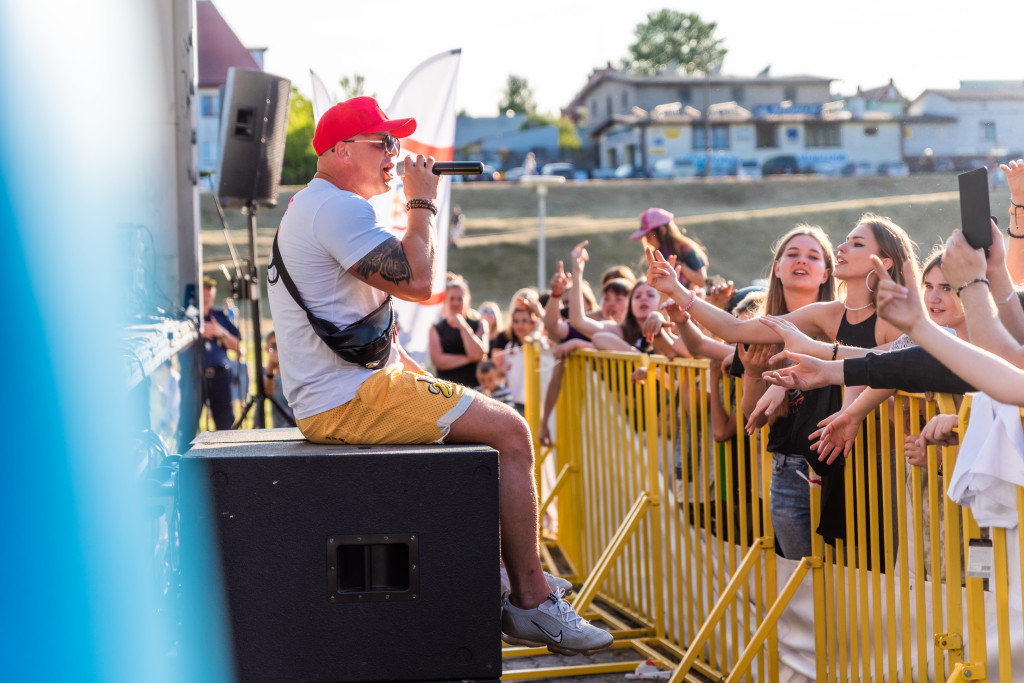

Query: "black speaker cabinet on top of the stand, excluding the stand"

xmin=214 ymin=67 xmax=292 ymax=206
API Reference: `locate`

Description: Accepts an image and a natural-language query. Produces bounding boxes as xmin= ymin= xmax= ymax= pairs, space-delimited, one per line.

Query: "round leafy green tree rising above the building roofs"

xmin=624 ymin=9 xmax=728 ymax=74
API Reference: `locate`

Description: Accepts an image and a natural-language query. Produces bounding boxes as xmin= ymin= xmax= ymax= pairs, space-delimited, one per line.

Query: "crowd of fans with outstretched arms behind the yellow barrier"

xmin=421 ymin=160 xmax=1024 ymax=558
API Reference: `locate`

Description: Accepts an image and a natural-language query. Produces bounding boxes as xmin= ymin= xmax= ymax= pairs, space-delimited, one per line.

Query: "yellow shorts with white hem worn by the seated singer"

xmin=297 ymin=364 xmax=473 ymax=443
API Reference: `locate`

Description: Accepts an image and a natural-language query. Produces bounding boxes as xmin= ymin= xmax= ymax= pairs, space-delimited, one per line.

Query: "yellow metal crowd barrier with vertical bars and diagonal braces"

xmin=512 ymin=350 xmax=1024 ymax=682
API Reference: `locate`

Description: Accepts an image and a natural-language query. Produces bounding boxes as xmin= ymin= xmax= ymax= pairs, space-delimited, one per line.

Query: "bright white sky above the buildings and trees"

xmin=213 ymin=0 xmax=1024 ymax=116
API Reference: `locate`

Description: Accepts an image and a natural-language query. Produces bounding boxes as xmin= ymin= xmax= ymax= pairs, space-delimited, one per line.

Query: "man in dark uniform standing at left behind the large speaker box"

xmin=203 ymin=275 xmax=240 ymax=429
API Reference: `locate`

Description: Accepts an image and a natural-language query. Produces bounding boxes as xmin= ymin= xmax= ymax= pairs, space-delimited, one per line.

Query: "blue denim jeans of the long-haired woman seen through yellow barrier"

xmin=771 ymin=453 xmax=811 ymax=560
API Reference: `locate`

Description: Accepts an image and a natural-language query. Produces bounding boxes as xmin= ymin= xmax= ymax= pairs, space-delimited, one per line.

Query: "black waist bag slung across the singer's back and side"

xmin=267 ymin=234 xmax=396 ymax=370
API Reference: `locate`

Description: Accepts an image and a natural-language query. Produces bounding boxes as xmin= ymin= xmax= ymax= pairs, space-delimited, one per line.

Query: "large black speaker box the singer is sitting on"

xmin=179 ymin=429 xmax=501 ymax=681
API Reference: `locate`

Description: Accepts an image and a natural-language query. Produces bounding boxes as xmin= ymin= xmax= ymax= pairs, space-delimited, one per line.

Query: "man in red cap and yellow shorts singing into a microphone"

xmin=267 ymin=97 xmax=612 ymax=654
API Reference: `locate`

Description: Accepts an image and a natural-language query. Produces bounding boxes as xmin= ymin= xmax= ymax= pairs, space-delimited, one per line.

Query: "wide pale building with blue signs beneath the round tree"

xmin=575 ymin=70 xmax=901 ymax=174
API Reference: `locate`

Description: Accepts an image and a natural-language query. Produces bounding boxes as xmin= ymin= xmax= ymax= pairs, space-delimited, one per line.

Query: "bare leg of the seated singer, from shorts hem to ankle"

xmin=444 ymin=394 xmax=551 ymax=609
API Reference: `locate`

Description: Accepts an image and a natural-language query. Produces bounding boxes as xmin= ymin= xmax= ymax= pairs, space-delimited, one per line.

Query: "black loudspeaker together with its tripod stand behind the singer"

xmin=207 ymin=67 xmax=292 ymax=429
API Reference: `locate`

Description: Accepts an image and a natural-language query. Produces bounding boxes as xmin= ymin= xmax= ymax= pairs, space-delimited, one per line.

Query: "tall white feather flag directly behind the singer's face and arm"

xmin=371 ymin=49 xmax=462 ymax=364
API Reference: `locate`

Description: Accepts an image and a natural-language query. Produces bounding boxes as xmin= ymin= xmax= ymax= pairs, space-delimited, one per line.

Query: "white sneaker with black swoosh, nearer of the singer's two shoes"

xmin=502 ymin=591 xmax=614 ymax=655
